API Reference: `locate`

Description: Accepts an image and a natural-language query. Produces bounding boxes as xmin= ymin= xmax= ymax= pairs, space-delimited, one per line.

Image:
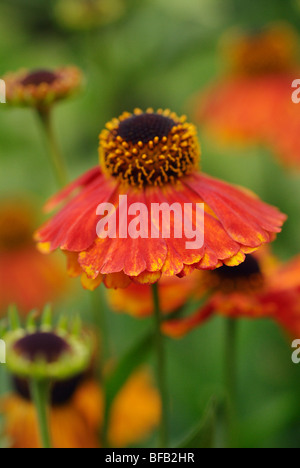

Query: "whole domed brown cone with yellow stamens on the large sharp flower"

xmin=99 ymin=109 xmax=200 ymax=188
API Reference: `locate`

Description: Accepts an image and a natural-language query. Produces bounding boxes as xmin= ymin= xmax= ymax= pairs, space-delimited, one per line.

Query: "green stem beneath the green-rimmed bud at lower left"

xmin=30 ymin=379 xmax=52 ymax=448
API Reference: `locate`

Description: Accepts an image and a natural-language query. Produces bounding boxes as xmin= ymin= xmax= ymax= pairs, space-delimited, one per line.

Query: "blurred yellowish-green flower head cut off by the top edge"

xmin=55 ymin=0 xmax=125 ymax=31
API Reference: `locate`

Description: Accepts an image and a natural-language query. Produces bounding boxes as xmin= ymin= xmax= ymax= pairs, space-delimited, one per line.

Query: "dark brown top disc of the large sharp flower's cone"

xmin=117 ymin=114 xmax=176 ymax=145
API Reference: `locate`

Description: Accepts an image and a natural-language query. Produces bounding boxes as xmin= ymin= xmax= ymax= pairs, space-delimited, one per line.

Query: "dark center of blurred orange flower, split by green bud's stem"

xmin=12 ymin=374 xmax=84 ymax=406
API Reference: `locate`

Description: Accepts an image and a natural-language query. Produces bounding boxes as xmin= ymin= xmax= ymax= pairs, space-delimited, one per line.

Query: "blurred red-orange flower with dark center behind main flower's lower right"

xmin=163 ymin=249 xmax=300 ymax=337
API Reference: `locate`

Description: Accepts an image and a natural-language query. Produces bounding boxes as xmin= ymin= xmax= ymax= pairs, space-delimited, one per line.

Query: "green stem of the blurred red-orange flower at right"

xmin=225 ymin=319 xmax=237 ymax=448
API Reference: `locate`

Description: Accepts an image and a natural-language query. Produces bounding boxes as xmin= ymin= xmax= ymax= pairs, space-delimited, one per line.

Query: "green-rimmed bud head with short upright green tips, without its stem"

xmin=4 ymin=307 xmax=93 ymax=380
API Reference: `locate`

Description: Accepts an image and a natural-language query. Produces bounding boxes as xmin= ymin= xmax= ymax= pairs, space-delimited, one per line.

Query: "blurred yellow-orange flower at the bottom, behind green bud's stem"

xmin=0 ymin=371 xmax=160 ymax=448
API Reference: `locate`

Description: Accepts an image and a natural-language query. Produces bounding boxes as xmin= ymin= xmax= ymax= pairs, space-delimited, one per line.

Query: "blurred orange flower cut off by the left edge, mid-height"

xmin=0 ymin=200 xmax=66 ymax=313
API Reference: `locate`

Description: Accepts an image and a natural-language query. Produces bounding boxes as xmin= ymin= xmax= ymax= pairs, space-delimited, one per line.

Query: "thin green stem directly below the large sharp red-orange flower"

xmin=152 ymin=284 xmax=169 ymax=448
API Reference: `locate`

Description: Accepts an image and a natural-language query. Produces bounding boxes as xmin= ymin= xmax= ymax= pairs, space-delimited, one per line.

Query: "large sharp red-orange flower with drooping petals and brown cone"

xmin=36 ymin=109 xmax=286 ymax=289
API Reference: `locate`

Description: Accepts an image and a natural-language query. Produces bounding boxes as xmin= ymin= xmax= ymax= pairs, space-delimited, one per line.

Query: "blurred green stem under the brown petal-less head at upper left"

xmin=38 ymin=109 xmax=68 ymax=188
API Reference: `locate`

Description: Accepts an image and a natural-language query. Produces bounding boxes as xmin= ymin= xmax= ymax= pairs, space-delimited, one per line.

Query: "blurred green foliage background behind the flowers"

xmin=0 ymin=0 xmax=300 ymax=448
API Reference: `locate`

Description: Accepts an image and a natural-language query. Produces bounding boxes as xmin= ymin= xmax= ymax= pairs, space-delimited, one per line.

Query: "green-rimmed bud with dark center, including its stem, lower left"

xmin=2 ymin=306 xmax=93 ymax=448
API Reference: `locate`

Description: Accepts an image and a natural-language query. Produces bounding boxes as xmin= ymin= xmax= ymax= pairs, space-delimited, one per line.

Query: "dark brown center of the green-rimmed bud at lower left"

xmin=14 ymin=332 xmax=70 ymax=363
